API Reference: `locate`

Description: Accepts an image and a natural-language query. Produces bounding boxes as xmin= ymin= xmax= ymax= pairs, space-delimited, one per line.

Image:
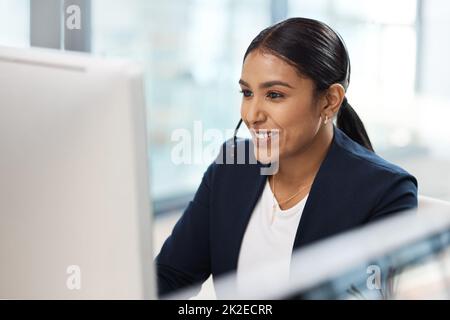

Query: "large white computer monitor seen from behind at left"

xmin=0 ymin=47 xmax=156 ymax=299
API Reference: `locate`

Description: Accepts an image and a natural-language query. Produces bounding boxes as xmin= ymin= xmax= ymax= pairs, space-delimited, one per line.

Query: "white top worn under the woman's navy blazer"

xmin=237 ymin=179 xmax=308 ymax=292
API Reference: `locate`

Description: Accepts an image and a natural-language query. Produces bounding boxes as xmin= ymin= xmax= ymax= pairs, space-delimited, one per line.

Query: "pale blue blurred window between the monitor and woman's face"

xmin=92 ymin=0 xmax=271 ymax=198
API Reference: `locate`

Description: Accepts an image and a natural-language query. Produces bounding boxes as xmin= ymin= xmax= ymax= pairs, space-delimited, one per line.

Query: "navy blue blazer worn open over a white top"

xmin=155 ymin=127 xmax=417 ymax=295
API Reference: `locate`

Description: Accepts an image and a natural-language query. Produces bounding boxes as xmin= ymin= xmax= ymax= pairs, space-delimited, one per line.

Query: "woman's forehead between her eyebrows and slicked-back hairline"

xmin=242 ymin=50 xmax=304 ymax=84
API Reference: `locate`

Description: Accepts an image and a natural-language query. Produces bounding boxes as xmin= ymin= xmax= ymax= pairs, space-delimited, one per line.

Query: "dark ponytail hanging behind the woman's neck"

xmin=336 ymin=97 xmax=375 ymax=152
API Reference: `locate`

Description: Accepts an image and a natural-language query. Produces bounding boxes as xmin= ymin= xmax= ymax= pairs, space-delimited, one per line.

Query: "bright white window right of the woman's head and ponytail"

xmin=288 ymin=0 xmax=417 ymax=152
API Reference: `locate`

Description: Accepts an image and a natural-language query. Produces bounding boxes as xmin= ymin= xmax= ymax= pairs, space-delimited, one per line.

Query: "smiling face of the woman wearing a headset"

xmin=239 ymin=49 xmax=321 ymax=163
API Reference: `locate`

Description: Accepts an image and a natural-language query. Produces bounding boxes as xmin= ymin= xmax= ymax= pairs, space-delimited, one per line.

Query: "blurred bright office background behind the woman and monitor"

xmin=0 ymin=0 xmax=450 ymax=300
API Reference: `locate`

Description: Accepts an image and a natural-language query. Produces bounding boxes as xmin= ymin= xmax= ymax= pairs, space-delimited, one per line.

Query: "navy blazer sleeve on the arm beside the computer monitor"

xmin=155 ymin=163 xmax=215 ymax=296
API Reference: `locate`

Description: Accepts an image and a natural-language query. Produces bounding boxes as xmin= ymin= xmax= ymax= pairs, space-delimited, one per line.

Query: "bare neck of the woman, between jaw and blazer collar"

xmin=276 ymin=125 xmax=334 ymax=186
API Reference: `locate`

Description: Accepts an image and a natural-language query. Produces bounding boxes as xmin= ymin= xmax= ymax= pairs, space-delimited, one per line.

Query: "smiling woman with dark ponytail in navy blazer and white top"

xmin=156 ymin=18 xmax=417 ymax=295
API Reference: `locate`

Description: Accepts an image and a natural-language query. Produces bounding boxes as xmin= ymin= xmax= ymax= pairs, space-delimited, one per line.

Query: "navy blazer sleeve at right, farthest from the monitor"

xmin=369 ymin=173 xmax=418 ymax=221
